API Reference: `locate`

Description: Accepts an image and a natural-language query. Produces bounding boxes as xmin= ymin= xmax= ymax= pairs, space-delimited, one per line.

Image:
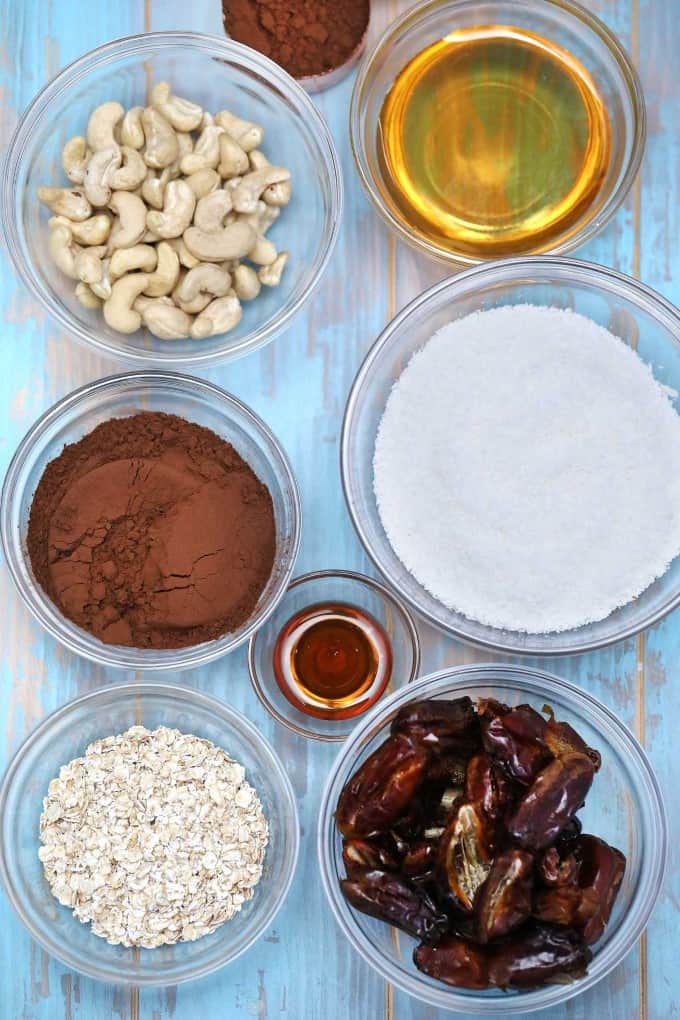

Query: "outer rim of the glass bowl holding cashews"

xmin=0 ymin=31 xmax=344 ymax=368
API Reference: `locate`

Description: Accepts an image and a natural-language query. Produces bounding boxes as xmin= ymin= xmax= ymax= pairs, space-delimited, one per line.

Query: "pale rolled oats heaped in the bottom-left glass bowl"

xmin=39 ymin=726 xmax=269 ymax=949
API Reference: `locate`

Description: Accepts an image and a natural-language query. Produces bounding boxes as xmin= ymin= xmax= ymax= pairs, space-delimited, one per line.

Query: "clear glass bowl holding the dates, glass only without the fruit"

xmin=317 ymin=664 xmax=668 ymax=1016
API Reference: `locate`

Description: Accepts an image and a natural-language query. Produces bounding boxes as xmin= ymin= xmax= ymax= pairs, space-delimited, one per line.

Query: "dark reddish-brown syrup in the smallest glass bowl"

xmin=274 ymin=602 xmax=391 ymax=719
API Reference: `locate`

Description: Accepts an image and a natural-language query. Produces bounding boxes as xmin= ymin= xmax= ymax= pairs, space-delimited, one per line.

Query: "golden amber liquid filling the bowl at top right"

xmin=378 ymin=24 xmax=611 ymax=259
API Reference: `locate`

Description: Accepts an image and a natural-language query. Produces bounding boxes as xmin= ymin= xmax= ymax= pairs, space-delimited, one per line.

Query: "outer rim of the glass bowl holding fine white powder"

xmin=339 ymin=255 xmax=680 ymax=657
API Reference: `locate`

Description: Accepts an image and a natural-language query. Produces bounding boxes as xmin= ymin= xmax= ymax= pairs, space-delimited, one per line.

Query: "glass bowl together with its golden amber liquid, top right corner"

xmin=350 ymin=0 xmax=645 ymax=265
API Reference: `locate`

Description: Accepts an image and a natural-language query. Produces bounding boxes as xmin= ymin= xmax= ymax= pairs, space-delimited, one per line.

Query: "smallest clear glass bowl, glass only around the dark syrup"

xmin=248 ymin=570 xmax=420 ymax=742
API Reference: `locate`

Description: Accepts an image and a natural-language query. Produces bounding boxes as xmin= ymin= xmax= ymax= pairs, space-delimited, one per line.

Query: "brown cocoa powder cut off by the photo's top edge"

xmin=222 ymin=0 xmax=370 ymax=78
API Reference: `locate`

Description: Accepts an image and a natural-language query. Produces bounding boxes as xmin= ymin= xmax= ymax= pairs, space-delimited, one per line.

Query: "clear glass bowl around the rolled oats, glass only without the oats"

xmin=0 ymin=683 xmax=300 ymax=986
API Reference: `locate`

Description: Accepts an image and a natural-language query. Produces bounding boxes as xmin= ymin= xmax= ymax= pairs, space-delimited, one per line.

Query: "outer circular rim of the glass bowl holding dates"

xmin=316 ymin=662 xmax=669 ymax=1016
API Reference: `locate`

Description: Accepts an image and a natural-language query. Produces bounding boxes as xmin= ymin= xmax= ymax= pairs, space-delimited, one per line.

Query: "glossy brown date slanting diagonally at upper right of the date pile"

xmin=508 ymin=752 xmax=594 ymax=850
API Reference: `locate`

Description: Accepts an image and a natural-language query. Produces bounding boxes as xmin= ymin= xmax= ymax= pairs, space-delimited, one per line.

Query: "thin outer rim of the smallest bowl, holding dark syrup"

xmin=248 ymin=569 xmax=420 ymax=744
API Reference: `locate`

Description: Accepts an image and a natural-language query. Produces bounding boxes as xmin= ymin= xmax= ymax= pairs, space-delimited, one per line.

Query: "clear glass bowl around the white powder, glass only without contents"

xmin=341 ymin=256 xmax=680 ymax=655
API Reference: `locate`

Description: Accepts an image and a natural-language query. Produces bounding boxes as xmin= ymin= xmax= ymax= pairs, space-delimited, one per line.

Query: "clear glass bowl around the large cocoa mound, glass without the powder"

xmin=0 ymin=372 xmax=300 ymax=670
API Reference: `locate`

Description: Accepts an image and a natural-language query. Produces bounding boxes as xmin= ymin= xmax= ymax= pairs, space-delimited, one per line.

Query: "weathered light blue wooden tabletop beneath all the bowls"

xmin=0 ymin=0 xmax=680 ymax=1020
